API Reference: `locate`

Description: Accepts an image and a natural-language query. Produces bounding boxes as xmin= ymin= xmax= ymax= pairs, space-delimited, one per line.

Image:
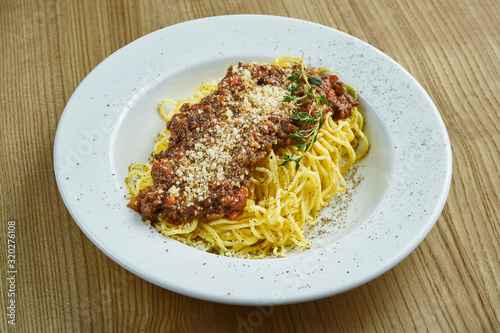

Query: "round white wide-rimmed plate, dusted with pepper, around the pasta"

xmin=54 ymin=15 xmax=451 ymax=304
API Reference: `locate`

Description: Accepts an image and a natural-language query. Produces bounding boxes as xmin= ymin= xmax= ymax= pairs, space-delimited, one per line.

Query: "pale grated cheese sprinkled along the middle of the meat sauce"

xmin=156 ymin=64 xmax=294 ymax=207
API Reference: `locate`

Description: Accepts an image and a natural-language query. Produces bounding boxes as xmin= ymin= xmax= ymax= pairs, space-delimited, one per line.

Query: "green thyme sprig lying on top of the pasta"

xmin=280 ymin=55 xmax=328 ymax=170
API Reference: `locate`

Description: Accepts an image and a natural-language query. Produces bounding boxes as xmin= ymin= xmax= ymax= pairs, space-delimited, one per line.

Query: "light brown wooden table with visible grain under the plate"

xmin=0 ymin=0 xmax=500 ymax=332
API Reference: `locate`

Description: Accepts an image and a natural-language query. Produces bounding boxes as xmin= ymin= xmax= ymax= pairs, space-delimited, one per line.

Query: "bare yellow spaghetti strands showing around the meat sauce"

xmin=126 ymin=56 xmax=369 ymax=258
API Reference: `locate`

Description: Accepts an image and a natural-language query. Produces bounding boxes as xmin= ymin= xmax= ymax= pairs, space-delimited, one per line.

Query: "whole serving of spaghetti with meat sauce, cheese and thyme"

xmin=126 ymin=56 xmax=369 ymax=258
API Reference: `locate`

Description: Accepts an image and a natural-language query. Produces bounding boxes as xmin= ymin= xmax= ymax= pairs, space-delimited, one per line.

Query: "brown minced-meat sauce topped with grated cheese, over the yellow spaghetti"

xmin=129 ymin=63 xmax=358 ymax=224
